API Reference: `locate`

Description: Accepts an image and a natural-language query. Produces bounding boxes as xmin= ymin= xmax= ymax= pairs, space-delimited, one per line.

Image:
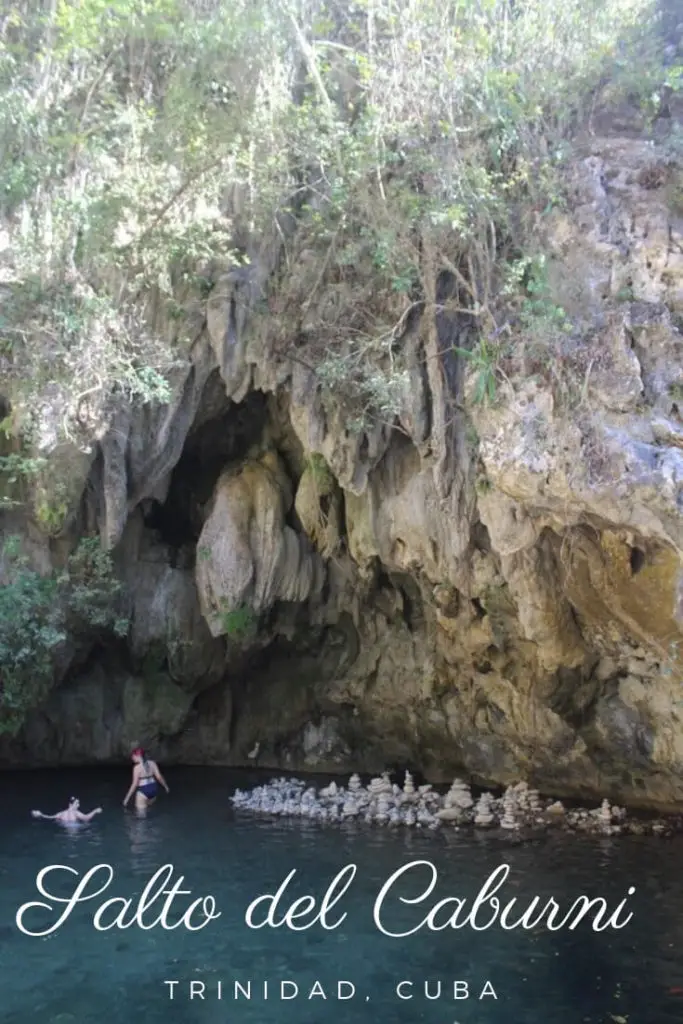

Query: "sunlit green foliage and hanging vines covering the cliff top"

xmin=0 ymin=0 xmax=671 ymax=426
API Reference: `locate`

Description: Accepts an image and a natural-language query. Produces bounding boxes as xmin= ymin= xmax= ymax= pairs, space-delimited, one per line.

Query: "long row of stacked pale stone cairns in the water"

xmin=230 ymin=772 xmax=681 ymax=836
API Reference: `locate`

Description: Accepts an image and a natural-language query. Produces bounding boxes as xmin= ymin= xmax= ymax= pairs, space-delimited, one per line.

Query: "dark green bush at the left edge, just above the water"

xmin=0 ymin=538 xmax=128 ymax=732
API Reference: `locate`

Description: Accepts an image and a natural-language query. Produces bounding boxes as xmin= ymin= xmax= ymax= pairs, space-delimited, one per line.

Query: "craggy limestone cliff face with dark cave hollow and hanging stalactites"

xmin=0 ymin=121 xmax=683 ymax=807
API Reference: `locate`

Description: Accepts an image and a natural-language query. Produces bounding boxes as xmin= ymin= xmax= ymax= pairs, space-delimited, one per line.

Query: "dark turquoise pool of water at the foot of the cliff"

xmin=0 ymin=769 xmax=683 ymax=1024
